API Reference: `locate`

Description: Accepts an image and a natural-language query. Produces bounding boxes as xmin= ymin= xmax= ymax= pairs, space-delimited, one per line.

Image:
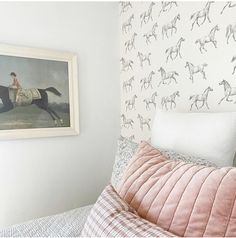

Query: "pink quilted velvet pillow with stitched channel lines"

xmin=118 ymin=142 xmax=236 ymax=237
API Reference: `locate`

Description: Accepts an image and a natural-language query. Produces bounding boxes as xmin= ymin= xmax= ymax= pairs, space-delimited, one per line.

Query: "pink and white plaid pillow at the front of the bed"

xmin=81 ymin=185 xmax=174 ymax=237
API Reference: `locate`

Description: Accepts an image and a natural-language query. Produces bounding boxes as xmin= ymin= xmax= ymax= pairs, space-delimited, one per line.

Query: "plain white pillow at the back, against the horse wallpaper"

xmin=151 ymin=110 xmax=236 ymax=166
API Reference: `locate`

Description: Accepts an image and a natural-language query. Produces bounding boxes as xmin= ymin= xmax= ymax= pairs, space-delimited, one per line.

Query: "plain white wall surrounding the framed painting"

xmin=0 ymin=2 xmax=120 ymax=227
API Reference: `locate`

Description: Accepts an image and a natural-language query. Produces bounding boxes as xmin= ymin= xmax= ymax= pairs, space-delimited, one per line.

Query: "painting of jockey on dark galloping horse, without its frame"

xmin=0 ymin=55 xmax=70 ymax=130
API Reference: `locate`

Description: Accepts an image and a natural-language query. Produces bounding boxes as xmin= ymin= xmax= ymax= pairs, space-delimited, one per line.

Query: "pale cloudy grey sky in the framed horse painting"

xmin=0 ymin=55 xmax=69 ymax=103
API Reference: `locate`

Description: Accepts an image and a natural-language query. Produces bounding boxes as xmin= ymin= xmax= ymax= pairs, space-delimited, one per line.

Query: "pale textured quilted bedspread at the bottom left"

xmin=0 ymin=206 xmax=92 ymax=237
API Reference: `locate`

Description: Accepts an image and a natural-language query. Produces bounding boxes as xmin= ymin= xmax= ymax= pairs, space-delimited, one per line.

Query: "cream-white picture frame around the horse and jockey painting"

xmin=0 ymin=44 xmax=79 ymax=140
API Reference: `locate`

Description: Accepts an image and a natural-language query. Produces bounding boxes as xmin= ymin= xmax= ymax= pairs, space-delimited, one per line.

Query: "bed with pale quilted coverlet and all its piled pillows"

xmin=0 ymin=112 xmax=236 ymax=237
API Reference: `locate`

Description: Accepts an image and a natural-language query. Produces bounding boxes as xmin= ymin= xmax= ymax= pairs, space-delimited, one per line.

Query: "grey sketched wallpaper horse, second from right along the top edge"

xmin=190 ymin=1 xmax=214 ymax=31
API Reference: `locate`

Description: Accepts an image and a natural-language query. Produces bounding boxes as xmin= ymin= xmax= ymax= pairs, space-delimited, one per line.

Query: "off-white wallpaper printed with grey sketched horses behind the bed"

xmin=120 ymin=1 xmax=236 ymax=141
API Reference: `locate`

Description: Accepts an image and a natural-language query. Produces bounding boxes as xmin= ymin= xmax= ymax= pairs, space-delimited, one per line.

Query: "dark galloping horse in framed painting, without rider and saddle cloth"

xmin=0 ymin=85 xmax=63 ymax=126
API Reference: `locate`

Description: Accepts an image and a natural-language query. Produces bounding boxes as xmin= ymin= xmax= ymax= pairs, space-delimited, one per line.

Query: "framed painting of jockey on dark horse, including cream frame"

xmin=0 ymin=44 xmax=79 ymax=139
